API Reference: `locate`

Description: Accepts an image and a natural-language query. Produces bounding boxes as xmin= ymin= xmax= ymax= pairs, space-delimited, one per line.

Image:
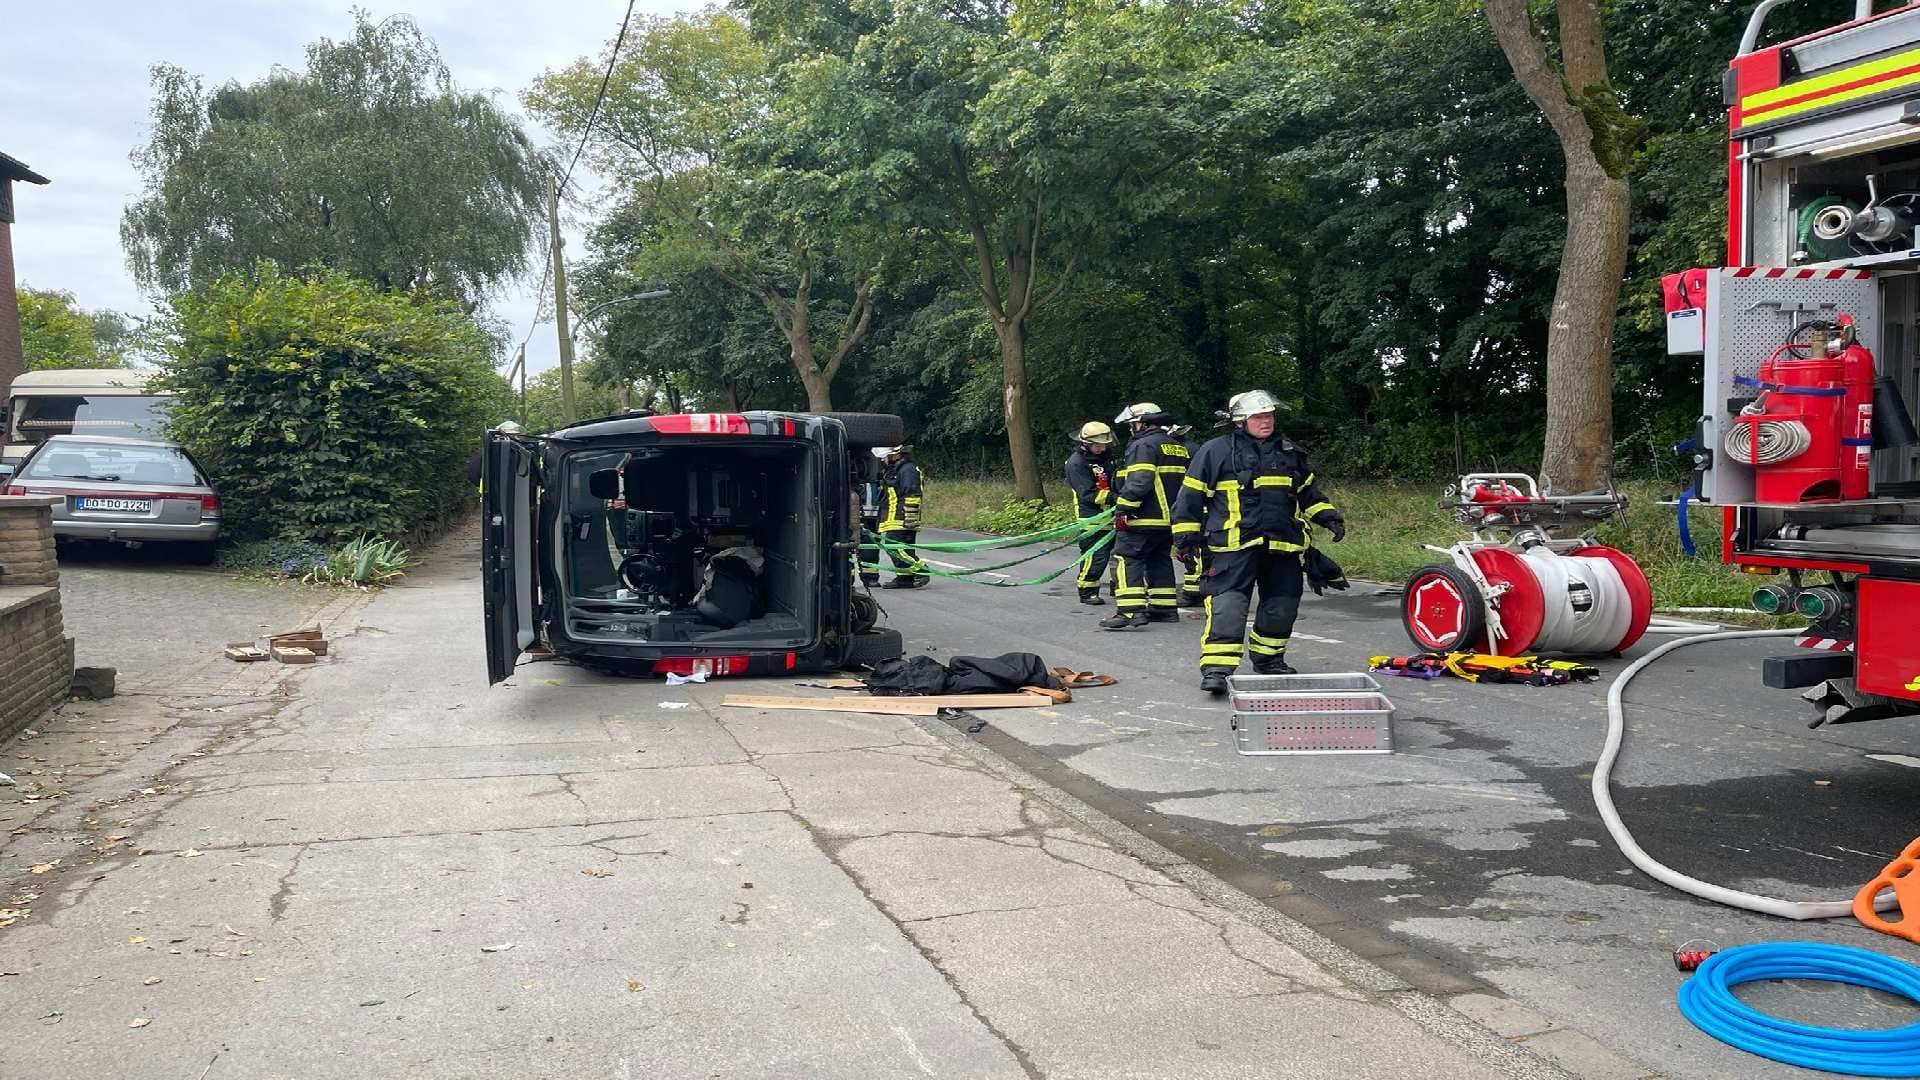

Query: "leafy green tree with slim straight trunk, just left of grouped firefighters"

xmin=747 ymin=0 xmax=1235 ymax=500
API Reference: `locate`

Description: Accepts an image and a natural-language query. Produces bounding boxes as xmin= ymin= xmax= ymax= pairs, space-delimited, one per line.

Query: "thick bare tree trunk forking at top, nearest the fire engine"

xmin=1484 ymin=0 xmax=1647 ymax=492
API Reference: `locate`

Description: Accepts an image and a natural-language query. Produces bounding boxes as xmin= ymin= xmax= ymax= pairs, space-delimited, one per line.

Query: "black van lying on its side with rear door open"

xmin=482 ymin=411 xmax=900 ymax=682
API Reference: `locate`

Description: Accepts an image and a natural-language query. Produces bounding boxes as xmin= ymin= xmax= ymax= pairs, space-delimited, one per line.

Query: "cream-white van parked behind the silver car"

xmin=0 ymin=367 xmax=171 ymax=477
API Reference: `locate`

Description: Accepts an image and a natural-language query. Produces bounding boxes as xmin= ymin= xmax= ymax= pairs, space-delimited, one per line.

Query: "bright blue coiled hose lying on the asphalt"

xmin=1678 ymin=942 xmax=1920 ymax=1076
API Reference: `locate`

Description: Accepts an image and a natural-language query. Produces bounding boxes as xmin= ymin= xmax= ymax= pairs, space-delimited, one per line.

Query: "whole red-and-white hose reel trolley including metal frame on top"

xmin=1402 ymin=473 xmax=1653 ymax=657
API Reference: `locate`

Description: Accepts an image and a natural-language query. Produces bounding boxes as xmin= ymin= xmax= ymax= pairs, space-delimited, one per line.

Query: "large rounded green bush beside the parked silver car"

xmin=159 ymin=263 xmax=511 ymax=546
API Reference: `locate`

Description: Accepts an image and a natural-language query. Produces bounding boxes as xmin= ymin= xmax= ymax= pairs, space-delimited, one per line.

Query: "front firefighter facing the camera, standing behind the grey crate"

xmin=1173 ymin=390 xmax=1346 ymax=694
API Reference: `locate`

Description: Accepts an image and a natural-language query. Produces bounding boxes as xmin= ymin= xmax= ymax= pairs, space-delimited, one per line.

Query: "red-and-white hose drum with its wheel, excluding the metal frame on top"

xmin=1402 ymin=544 xmax=1653 ymax=655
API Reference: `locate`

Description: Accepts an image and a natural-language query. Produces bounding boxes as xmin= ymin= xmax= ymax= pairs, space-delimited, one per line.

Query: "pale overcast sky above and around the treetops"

xmin=0 ymin=0 xmax=691 ymax=371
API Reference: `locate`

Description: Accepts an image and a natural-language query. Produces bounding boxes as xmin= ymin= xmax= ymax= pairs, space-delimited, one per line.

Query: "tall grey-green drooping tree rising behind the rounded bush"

xmin=121 ymin=12 xmax=543 ymax=307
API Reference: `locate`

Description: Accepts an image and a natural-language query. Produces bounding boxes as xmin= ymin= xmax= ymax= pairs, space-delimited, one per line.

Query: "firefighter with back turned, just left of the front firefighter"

xmin=1100 ymin=402 xmax=1188 ymax=630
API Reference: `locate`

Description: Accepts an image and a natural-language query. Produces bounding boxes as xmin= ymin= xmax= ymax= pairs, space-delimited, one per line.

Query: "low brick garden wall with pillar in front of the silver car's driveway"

xmin=0 ymin=496 xmax=73 ymax=738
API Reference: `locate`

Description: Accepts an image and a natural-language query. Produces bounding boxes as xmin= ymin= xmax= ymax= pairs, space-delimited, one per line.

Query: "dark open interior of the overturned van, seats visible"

xmin=547 ymin=442 xmax=822 ymax=648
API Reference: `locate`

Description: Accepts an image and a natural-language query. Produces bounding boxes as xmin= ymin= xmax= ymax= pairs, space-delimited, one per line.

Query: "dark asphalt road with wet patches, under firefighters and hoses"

xmin=879 ymin=532 xmax=1920 ymax=1078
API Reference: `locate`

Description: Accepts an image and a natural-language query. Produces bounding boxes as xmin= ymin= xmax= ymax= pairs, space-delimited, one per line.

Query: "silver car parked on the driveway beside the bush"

xmin=6 ymin=434 xmax=221 ymax=559
